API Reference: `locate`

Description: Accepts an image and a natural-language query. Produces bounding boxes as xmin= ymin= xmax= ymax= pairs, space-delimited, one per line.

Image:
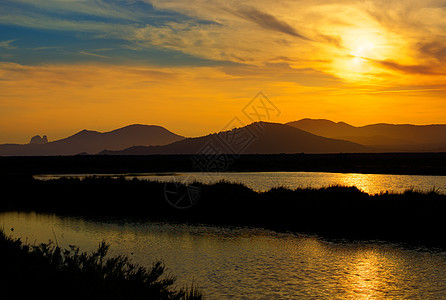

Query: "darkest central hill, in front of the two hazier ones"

xmin=100 ymin=122 xmax=373 ymax=155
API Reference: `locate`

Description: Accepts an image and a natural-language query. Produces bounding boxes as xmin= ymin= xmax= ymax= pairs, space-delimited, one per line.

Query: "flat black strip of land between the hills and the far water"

xmin=0 ymin=153 xmax=446 ymax=175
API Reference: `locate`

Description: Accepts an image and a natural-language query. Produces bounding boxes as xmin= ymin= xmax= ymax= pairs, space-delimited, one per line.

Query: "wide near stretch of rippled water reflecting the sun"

xmin=0 ymin=212 xmax=446 ymax=299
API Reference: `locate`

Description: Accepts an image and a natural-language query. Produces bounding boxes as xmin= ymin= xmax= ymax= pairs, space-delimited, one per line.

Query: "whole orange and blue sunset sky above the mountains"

xmin=0 ymin=0 xmax=446 ymax=143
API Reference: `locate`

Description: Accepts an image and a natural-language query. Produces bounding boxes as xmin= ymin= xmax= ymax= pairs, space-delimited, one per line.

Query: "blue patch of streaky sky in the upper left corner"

xmin=0 ymin=0 xmax=223 ymax=66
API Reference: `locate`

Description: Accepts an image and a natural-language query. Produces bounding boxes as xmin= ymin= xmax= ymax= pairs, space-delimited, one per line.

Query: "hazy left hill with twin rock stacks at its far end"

xmin=0 ymin=125 xmax=184 ymax=156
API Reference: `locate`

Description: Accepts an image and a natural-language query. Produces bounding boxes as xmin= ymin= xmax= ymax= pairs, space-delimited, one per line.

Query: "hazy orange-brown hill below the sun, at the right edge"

xmin=287 ymin=119 xmax=446 ymax=152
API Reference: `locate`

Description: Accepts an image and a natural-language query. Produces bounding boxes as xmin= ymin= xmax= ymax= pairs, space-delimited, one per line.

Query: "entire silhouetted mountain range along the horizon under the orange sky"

xmin=0 ymin=119 xmax=446 ymax=156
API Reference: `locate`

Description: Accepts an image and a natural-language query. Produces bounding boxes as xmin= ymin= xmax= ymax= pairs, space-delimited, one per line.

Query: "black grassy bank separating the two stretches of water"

xmin=0 ymin=177 xmax=446 ymax=247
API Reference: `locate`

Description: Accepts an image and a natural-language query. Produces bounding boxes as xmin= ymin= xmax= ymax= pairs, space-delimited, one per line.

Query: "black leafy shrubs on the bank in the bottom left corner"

xmin=0 ymin=231 xmax=202 ymax=300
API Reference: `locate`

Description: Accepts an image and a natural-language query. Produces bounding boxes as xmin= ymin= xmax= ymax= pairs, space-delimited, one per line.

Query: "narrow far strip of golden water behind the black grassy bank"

xmin=35 ymin=172 xmax=446 ymax=194
